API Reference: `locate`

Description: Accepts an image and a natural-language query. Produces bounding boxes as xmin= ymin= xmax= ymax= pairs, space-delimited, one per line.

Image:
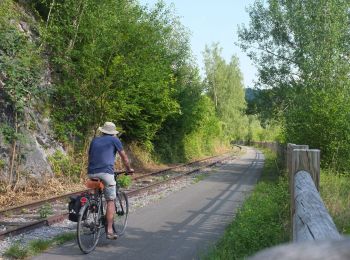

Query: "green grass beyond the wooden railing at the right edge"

xmin=320 ymin=170 xmax=350 ymax=235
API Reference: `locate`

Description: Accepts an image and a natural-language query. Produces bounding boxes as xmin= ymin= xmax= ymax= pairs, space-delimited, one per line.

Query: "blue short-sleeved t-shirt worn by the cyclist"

xmin=88 ymin=135 xmax=123 ymax=174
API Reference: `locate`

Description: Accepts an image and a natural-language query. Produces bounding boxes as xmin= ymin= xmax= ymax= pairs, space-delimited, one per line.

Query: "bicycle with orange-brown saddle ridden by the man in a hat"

xmin=77 ymin=171 xmax=129 ymax=254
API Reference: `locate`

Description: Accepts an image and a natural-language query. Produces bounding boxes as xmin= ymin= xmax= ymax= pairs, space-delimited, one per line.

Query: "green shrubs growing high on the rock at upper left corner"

xmin=0 ymin=0 xmax=42 ymax=116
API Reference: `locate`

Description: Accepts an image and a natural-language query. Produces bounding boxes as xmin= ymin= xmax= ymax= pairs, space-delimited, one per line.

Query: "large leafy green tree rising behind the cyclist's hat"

xmin=39 ymin=0 xmax=188 ymax=146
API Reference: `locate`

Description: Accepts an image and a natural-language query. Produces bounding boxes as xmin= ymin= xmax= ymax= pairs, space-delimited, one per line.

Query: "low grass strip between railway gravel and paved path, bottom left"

xmin=0 ymin=232 xmax=76 ymax=259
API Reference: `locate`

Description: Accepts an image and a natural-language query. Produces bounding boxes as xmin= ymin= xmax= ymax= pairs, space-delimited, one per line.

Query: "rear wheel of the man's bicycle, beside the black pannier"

xmin=77 ymin=202 xmax=102 ymax=254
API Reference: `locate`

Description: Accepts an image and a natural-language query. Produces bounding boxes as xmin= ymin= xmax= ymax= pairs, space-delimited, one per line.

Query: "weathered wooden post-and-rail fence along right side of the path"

xmin=247 ymin=142 xmax=350 ymax=259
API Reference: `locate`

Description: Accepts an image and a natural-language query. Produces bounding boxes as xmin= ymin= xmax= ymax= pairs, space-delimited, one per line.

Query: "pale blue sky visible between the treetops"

xmin=139 ymin=0 xmax=257 ymax=87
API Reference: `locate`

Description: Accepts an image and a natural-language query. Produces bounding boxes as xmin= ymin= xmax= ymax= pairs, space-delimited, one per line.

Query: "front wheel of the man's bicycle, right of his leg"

xmin=113 ymin=191 xmax=129 ymax=236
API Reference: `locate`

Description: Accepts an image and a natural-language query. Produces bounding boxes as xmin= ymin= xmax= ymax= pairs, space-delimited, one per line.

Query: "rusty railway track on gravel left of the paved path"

xmin=0 ymin=147 xmax=241 ymax=240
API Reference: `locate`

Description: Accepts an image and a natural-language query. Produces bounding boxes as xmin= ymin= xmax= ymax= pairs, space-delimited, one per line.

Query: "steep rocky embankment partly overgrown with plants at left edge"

xmin=0 ymin=3 xmax=63 ymax=184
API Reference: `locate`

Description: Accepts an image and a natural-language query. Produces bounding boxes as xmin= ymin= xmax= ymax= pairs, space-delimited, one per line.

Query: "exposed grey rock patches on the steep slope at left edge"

xmin=0 ymin=13 xmax=64 ymax=184
